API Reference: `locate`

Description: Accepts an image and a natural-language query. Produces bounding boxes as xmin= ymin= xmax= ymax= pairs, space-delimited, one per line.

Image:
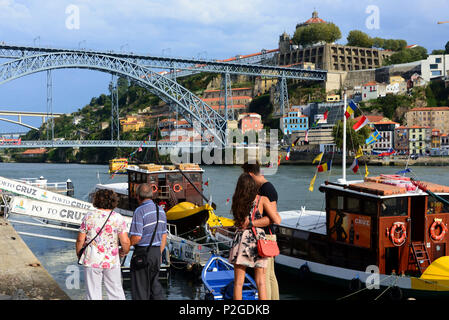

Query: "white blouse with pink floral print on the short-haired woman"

xmin=79 ymin=210 xmax=127 ymax=269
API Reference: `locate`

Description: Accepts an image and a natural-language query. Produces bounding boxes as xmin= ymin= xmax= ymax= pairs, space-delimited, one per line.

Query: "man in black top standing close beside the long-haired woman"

xmin=242 ymin=162 xmax=279 ymax=300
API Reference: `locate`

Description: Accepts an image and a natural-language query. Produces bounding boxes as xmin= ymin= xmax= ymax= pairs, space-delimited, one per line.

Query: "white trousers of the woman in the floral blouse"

xmin=84 ymin=267 xmax=126 ymax=300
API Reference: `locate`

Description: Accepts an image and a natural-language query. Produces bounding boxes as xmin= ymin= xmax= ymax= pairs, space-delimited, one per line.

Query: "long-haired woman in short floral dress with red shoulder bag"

xmin=229 ymin=173 xmax=281 ymax=300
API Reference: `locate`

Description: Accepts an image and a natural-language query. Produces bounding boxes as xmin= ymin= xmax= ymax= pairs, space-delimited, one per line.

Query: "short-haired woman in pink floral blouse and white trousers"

xmin=76 ymin=189 xmax=130 ymax=300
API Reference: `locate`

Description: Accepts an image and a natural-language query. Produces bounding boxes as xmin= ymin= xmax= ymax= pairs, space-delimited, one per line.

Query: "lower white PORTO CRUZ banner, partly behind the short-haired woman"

xmin=10 ymin=197 xmax=132 ymax=230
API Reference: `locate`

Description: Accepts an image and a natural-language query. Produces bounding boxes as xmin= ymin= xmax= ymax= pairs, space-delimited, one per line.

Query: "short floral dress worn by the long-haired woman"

xmin=229 ymin=196 xmax=268 ymax=268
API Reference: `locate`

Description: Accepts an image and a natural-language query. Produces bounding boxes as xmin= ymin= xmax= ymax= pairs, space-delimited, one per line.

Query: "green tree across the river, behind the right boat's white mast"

xmin=332 ymin=119 xmax=371 ymax=152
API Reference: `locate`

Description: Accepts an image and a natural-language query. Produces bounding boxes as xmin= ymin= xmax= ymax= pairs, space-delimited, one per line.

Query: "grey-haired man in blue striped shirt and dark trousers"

xmin=129 ymin=184 xmax=167 ymax=300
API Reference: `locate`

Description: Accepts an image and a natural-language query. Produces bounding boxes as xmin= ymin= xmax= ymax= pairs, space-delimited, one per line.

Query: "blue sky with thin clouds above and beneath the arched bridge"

xmin=0 ymin=0 xmax=449 ymax=133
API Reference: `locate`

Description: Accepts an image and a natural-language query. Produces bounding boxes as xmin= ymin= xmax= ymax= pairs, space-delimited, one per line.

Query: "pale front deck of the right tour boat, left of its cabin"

xmin=279 ymin=210 xmax=326 ymax=235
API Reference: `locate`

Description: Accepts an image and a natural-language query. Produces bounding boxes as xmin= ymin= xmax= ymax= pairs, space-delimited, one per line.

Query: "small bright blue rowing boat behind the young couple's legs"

xmin=201 ymin=255 xmax=258 ymax=300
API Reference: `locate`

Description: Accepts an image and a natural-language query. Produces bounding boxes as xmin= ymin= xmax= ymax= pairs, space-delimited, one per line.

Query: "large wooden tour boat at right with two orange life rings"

xmin=275 ymin=94 xmax=449 ymax=298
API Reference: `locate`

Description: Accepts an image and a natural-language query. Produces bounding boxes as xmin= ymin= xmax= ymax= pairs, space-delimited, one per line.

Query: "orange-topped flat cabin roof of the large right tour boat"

xmin=320 ymin=175 xmax=449 ymax=198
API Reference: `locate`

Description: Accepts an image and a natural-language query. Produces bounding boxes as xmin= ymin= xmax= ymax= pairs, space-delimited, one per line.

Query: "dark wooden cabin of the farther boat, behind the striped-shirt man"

xmin=127 ymin=164 xmax=204 ymax=211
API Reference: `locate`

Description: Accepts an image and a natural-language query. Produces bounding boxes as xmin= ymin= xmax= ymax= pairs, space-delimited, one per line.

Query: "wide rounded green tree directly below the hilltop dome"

xmin=292 ymin=23 xmax=341 ymax=46
